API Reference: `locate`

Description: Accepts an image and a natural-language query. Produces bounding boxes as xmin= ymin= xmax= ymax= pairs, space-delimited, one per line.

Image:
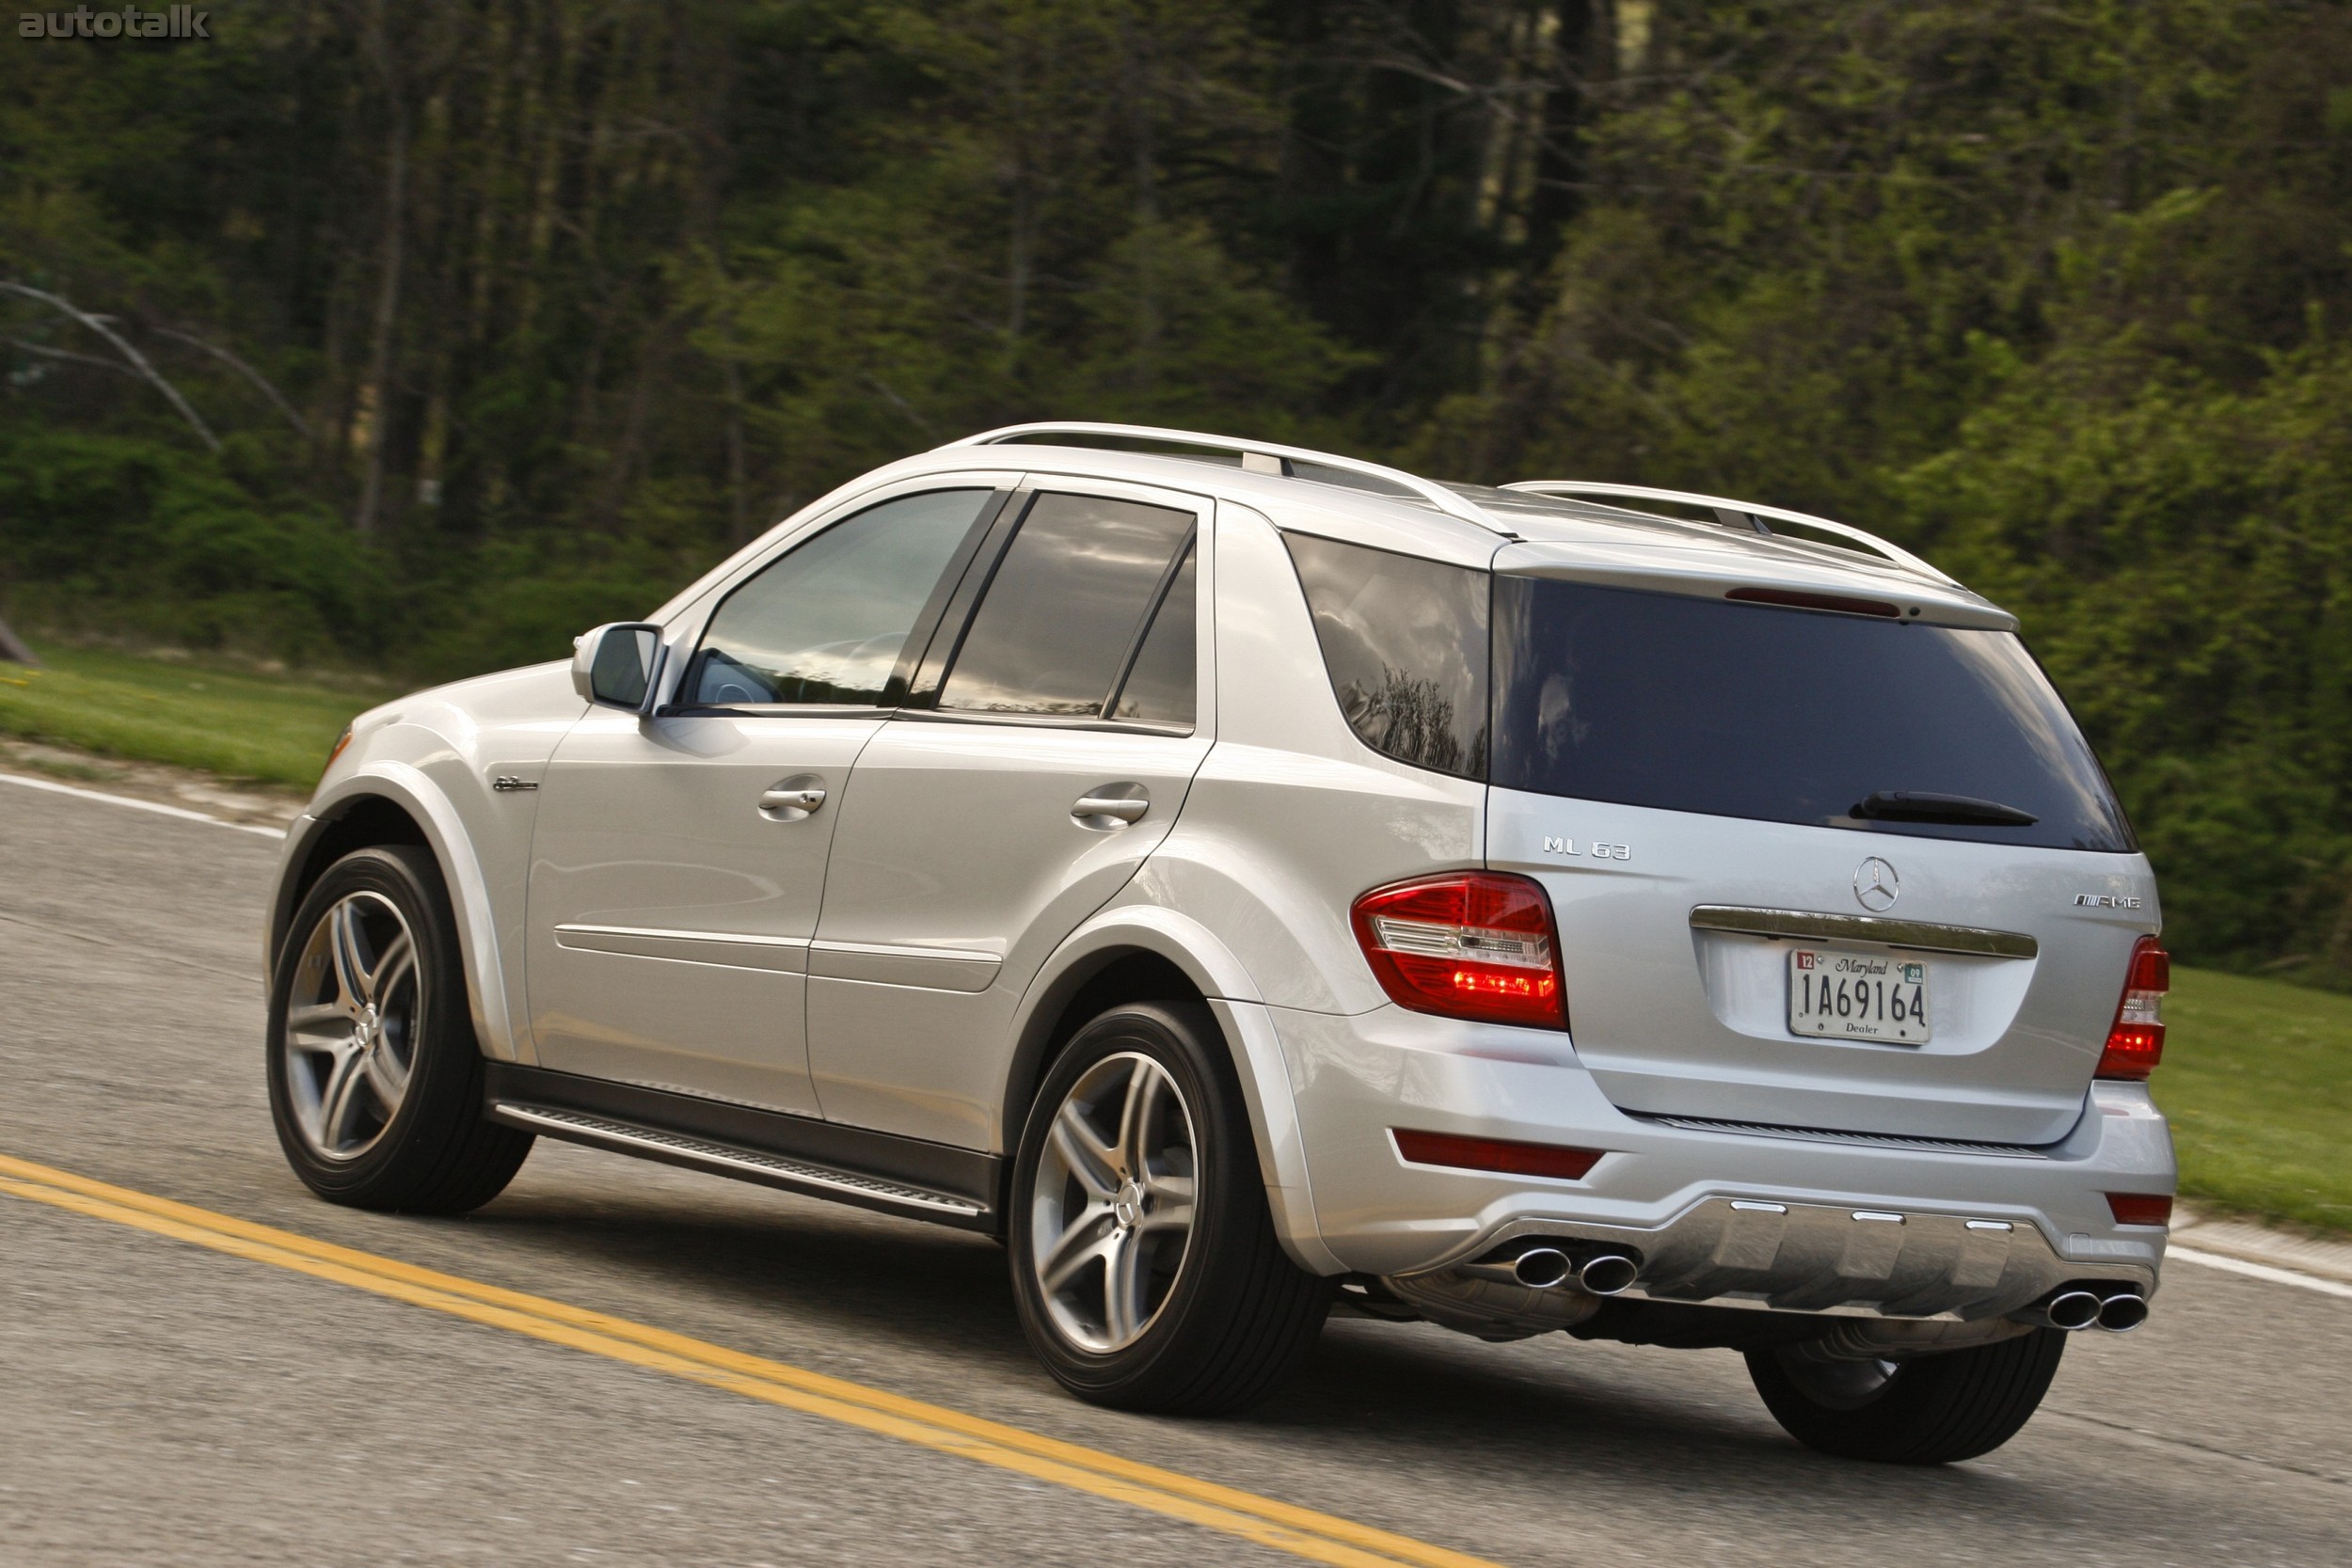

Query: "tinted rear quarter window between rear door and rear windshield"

xmin=1282 ymin=533 xmax=1491 ymax=778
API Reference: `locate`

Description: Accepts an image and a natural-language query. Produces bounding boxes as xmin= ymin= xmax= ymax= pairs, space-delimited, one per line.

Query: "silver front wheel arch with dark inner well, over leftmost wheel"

xmin=263 ymin=762 xmax=516 ymax=1060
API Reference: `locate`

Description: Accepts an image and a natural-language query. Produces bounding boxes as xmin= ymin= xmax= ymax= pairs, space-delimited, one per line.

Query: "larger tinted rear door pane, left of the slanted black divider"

xmin=939 ymin=494 xmax=1193 ymax=715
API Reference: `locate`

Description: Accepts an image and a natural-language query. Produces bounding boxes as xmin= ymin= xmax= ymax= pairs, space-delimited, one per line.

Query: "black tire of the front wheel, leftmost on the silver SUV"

xmin=266 ymin=844 xmax=532 ymax=1213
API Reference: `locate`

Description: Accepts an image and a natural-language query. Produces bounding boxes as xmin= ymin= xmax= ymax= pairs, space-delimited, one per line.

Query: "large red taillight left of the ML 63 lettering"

xmin=1353 ymin=872 xmax=1569 ymax=1030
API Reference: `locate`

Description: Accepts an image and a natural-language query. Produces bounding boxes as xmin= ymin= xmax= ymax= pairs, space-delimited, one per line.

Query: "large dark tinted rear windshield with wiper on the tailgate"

xmin=1491 ymin=576 xmax=2134 ymax=851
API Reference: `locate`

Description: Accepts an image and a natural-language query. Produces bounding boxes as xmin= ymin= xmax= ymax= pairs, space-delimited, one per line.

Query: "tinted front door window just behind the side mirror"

xmin=682 ymin=489 xmax=993 ymax=705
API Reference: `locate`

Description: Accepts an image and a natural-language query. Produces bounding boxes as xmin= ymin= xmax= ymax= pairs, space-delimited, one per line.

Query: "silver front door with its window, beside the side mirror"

xmin=530 ymin=486 xmax=997 ymax=1115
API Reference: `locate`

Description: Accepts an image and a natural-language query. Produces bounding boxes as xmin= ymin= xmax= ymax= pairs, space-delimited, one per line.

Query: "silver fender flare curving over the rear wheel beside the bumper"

xmin=1005 ymin=903 xmax=1348 ymax=1275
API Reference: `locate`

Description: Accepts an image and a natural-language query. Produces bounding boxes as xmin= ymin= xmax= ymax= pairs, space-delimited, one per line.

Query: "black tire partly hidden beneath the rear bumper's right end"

xmin=1748 ymin=1328 xmax=2068 ymax=1465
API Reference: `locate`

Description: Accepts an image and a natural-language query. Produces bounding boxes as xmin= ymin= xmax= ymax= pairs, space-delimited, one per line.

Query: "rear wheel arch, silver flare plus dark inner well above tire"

xmin=997 ymin=905 xmax=1343 ymax=1275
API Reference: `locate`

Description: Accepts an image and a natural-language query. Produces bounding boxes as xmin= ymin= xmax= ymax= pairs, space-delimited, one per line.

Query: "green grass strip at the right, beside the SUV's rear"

xmin=2154 ymin=969 xmax=2352 ymax=1232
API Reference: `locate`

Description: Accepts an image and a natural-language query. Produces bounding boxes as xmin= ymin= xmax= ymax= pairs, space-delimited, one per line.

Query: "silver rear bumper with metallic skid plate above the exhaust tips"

xmin=1273 ymin=1006 xmax=2173 ymax=1319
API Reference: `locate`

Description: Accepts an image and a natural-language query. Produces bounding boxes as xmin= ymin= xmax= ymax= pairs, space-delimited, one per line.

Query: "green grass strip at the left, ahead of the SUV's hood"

xmin=0 ymin=644 xmax=389 ymax=787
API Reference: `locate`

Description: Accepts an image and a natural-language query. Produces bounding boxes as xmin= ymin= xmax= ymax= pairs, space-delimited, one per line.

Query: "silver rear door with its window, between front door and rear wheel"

xmin=809 ymin=482 xmax=1214 ymax=1148
